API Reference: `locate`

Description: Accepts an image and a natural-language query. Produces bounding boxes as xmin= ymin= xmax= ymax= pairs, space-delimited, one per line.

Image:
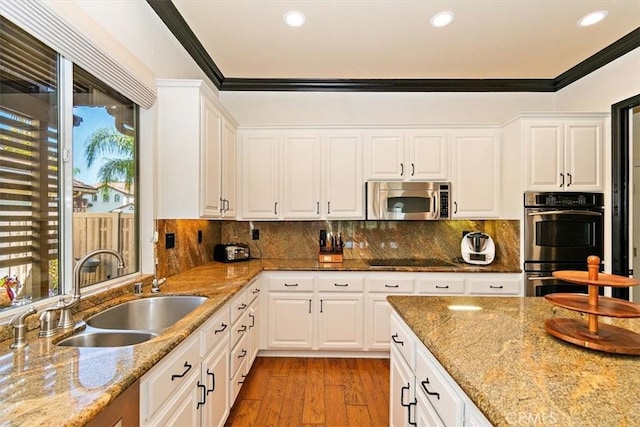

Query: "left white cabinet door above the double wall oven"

xmin=523 ymin=121 xmax=564 ymax=191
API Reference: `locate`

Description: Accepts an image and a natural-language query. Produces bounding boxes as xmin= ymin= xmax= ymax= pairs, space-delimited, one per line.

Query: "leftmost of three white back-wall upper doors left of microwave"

xmin=240 ymin=131 xmax=282 ymax=219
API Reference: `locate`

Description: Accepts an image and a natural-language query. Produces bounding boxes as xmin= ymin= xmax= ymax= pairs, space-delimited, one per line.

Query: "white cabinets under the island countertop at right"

xmin=389 ymin=312 xmax=491 ymax=427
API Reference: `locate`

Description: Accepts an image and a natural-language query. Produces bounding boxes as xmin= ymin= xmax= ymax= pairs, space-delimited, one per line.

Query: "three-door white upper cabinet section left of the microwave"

xmin=240 ymin=129 xmax=364 ymax=220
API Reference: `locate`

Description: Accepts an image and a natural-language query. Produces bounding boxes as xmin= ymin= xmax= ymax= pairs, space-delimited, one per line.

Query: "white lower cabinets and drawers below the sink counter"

xmin=140 ymin=282 xmax=259 ymax=427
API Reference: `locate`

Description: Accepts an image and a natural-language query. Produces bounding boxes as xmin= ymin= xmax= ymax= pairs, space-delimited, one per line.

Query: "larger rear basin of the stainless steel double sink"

xmin=86 ymin=295 xmax=207 ymax=333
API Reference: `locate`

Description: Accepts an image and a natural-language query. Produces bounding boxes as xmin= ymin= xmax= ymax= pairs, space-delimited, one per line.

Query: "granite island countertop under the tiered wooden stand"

xmin=388 ymin=296 xmax=640 ymax=427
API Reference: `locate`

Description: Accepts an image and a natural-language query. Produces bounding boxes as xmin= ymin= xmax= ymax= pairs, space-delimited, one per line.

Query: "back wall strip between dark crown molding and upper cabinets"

xmin=220 ymin=92 xmax=555 ymax=126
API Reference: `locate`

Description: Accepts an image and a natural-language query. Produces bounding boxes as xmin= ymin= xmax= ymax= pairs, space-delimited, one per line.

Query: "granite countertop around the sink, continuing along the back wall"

xmin=0 ymin=259 xmax=520 ymax=426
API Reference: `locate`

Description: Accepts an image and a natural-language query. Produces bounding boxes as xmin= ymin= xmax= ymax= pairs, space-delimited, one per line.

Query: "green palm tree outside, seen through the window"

xmin=84 ymin=127 xmax=135 ymax=191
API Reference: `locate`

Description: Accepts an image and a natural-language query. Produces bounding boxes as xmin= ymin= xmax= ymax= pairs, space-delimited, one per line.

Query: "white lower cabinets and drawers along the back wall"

xmin=262 ymin=271 xmax=523 ymax=351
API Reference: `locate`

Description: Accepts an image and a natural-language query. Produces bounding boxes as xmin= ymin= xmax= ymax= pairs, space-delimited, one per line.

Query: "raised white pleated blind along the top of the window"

xmin=0 ymin=0 xmax=156 ymax=108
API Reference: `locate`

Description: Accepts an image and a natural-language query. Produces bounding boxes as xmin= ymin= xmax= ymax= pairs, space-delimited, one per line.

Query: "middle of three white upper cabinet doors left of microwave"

xmin=282 ymin=131 xmax=320 ymax=219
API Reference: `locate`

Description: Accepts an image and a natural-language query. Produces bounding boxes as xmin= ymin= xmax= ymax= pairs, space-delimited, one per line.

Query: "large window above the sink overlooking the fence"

xmin=0 ymin=16 xmax=138 ymax=310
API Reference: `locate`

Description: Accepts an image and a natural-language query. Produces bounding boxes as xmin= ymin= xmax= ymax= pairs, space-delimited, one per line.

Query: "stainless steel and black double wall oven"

xmin=524 ymin=192 xmax=604 ymax=296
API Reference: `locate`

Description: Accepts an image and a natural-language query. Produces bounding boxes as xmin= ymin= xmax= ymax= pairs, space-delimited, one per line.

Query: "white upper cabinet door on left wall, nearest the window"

xmin=201 ymin=96 xmax=222 ymax=218
